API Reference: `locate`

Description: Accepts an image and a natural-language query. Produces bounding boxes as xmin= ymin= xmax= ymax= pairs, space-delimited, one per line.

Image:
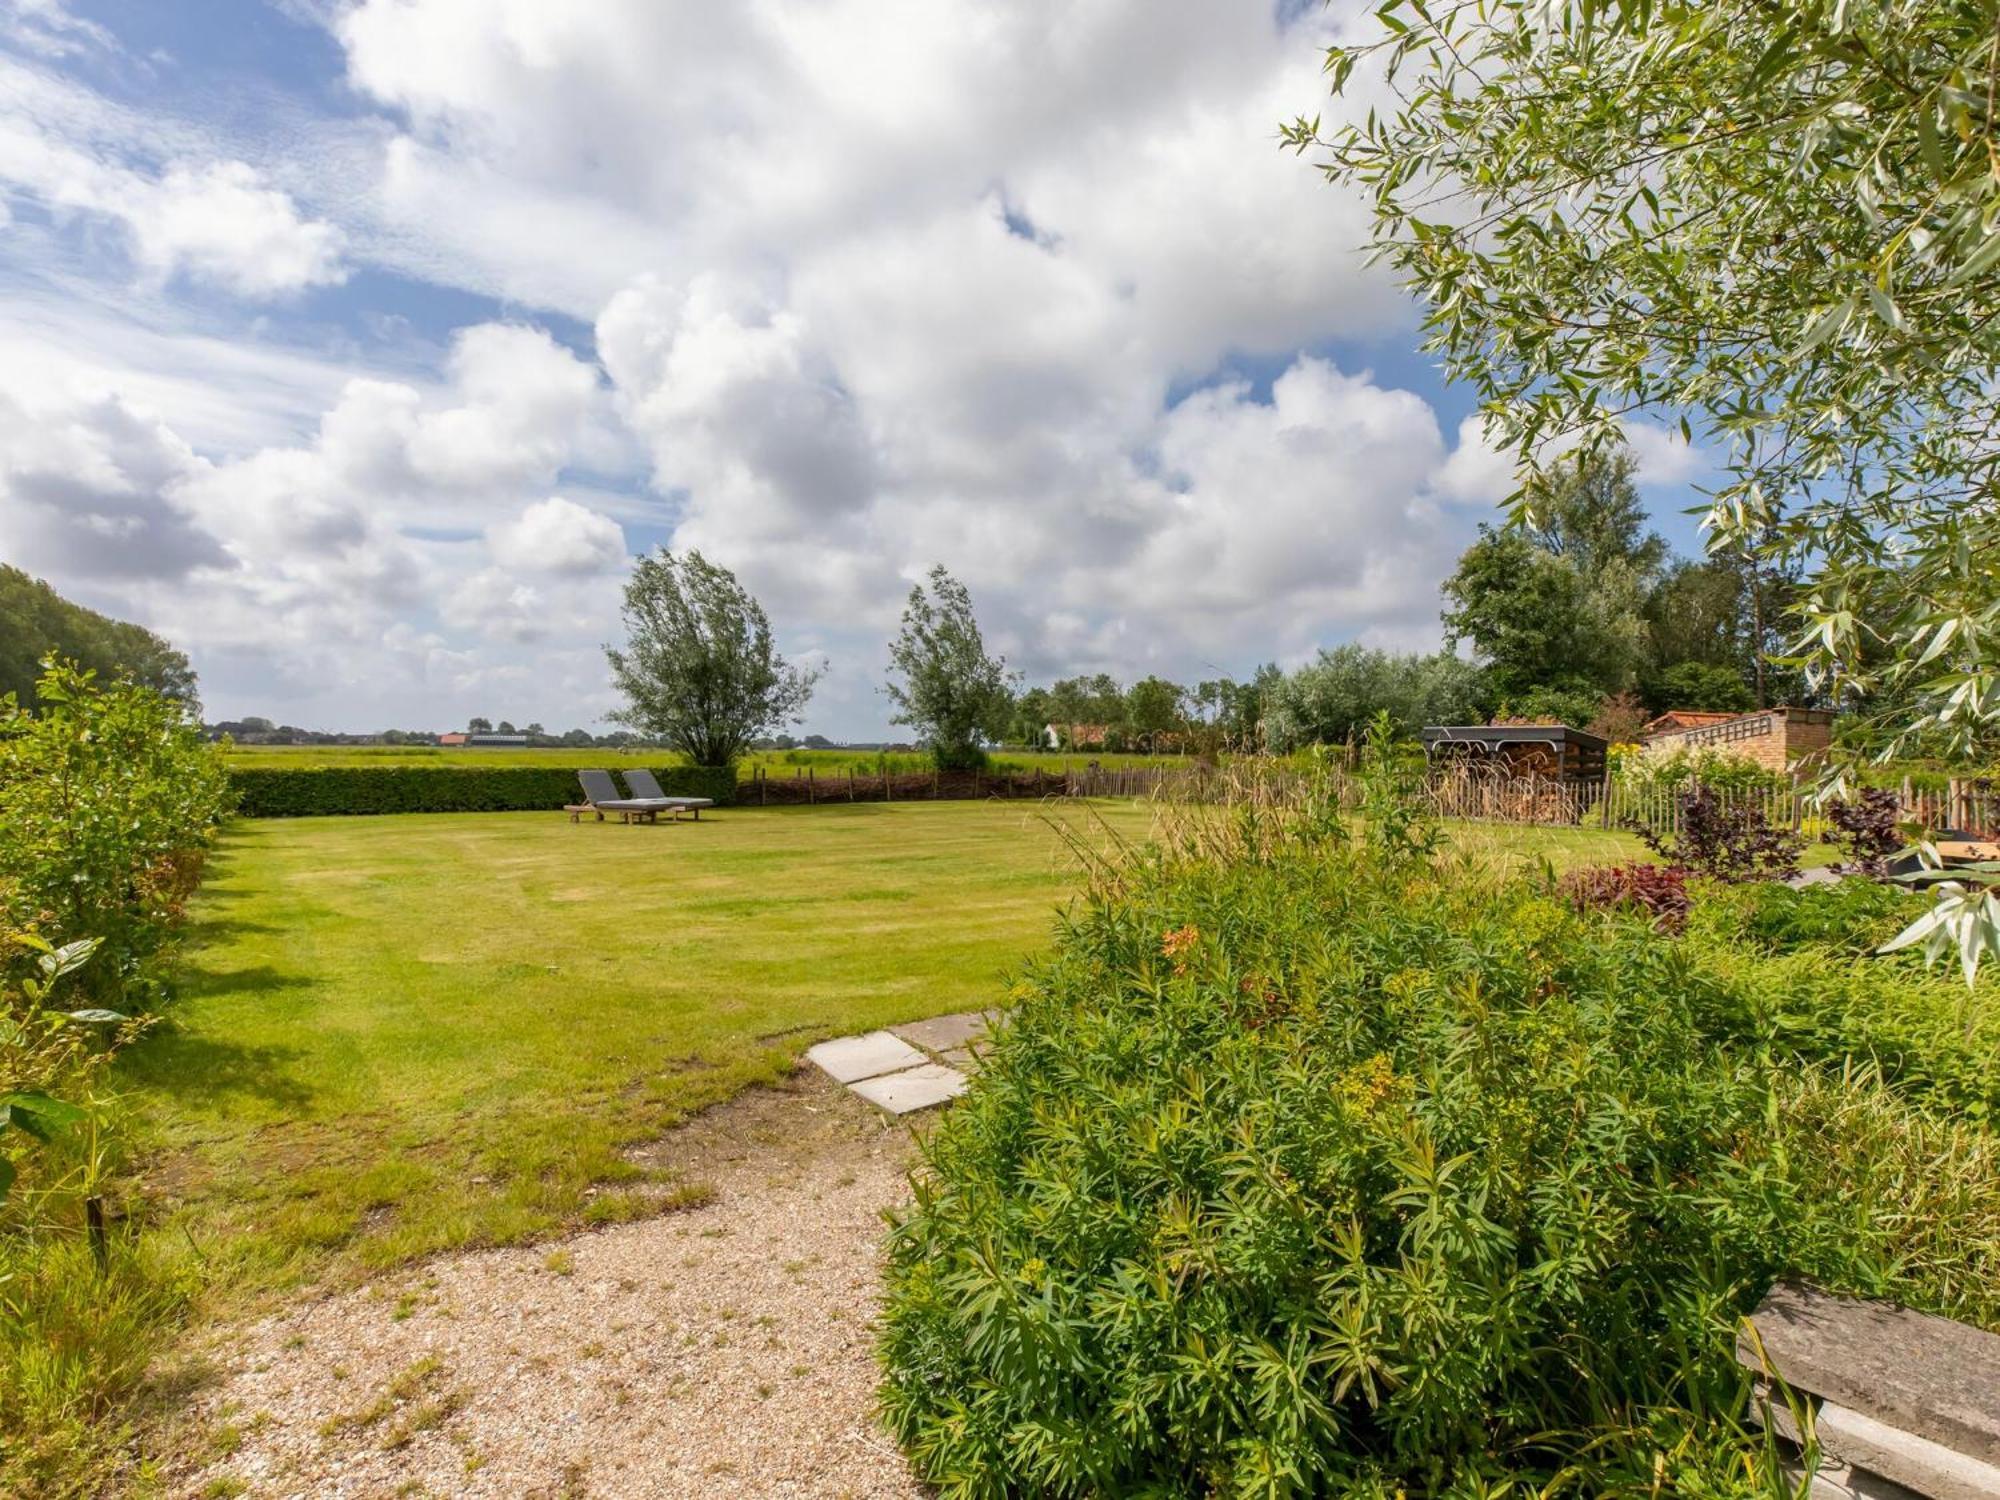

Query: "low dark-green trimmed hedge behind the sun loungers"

xmin=230 ymin=766 xmax=736 ymax=818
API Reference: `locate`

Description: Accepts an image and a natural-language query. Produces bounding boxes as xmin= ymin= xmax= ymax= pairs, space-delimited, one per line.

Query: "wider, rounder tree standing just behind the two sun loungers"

xmin=604 ymin=546 xmax=820 ymax=766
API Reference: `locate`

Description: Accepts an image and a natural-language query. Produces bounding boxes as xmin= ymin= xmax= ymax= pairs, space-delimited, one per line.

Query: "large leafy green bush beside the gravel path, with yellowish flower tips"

xmin=882 ymin=844 xmax=2000 ymax=1496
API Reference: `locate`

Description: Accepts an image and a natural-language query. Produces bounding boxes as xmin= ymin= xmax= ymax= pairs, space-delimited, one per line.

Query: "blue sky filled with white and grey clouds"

xmin=0 ymin=0 xmax=1704 ymax=740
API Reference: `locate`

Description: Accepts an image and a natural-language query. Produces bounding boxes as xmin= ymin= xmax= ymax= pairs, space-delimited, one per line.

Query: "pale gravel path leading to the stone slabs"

xmin=184 ymin=1074 xmax=926 ymax=1500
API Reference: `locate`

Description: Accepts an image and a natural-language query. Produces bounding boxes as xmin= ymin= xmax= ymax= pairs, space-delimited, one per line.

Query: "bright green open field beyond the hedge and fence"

xmin=226 ymin=744 xmax=1188 ymax=780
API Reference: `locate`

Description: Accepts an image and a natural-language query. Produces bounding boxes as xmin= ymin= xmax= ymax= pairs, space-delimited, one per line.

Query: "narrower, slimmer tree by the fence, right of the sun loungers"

xmin=884 ymin=564 xmax=1012 ymax=770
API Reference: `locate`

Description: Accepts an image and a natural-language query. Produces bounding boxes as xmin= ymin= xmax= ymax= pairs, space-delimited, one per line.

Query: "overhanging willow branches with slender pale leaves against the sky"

xmin=1286 ymin=0 xmax=2000 ymax=980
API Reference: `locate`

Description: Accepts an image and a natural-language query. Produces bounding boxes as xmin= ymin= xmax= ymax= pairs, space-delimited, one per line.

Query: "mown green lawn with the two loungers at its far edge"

xmin=120 ymin=802 xmax=1150 ymax=1286
